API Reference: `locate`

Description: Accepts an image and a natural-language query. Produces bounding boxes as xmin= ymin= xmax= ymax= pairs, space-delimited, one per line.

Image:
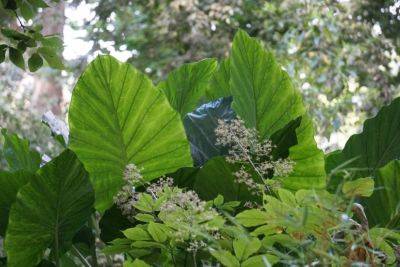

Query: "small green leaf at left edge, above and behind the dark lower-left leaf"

xmin=1 ymin=129 xmax=41 ymax=172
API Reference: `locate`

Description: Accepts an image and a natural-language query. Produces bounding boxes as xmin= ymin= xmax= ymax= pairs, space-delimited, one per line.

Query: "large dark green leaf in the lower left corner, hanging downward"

xmin=5 ymin=150 xmax=94 ymax=267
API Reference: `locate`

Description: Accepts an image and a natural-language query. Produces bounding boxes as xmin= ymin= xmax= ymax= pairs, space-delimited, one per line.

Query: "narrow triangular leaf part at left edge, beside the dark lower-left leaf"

xmin=0 ymin=171 xmax=33 ymax=236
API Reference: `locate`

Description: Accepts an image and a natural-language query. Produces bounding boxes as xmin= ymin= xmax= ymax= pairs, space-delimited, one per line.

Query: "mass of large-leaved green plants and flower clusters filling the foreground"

xmin=0 ymin=30 xmax=400 ymax=267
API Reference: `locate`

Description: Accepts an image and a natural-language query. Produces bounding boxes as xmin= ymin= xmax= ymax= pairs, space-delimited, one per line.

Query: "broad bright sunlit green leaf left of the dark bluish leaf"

xmin=69 ymin=56 xmax=192 ymax=211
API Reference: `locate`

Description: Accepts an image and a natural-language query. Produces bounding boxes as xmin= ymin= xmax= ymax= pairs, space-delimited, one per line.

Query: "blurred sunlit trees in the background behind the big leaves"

xmin=0 ymin=0 xmax=400 ymax=157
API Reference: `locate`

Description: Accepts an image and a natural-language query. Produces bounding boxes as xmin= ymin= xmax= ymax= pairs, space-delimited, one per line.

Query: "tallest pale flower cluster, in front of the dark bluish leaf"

xmin=215 ymin=119 xmax=294 ymax=191
